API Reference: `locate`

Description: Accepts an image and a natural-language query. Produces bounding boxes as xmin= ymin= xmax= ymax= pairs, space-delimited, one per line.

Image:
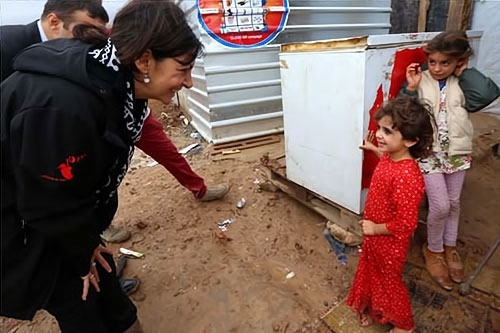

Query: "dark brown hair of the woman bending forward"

xmin=73 ymin=0 xmax=203 ymax=70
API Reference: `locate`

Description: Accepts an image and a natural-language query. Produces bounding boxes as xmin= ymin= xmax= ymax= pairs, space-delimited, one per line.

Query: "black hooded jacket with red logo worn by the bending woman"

xmin=0 ymin=39 xmax=132 ymax=319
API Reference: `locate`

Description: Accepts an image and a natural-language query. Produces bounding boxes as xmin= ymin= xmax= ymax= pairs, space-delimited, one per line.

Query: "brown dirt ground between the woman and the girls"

xmin=0 ymin=105 xmax=500 ymax=333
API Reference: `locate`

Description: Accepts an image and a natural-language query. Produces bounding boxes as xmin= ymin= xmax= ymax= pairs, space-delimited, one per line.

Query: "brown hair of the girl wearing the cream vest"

xmin=424 ymin=30 xmax=473 ymax=59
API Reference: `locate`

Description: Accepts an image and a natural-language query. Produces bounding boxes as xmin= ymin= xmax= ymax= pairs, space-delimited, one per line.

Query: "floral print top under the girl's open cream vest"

xmin=419 ymin=80 xmax=472 ymax=174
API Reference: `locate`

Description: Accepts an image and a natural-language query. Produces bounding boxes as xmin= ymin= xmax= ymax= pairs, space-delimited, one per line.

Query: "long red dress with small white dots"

xmin=347 ymin=154 xmax=424 ymax=330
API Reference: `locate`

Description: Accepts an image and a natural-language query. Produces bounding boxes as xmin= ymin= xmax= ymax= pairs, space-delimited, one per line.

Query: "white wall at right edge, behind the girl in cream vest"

xmin=471 ymin=0 xmax=500 ymax=114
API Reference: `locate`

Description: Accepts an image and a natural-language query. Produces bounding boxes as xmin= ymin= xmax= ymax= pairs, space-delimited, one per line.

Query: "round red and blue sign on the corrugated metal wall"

xmin=197 ymin=0 xmax=289 ymax=48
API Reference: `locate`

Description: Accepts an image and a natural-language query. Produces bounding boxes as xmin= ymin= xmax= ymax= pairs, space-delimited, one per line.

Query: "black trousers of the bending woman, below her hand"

xmin=44 ymin=254 xmax=137 ymax=333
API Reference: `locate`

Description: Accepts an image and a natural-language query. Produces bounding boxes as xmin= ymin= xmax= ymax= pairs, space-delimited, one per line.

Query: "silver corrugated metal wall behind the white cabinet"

xmin=183 ymin=0 xmax=391 ymax=143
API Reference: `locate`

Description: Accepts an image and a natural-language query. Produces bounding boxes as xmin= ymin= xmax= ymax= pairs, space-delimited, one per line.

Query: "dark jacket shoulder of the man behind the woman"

xmin=0 ymin=21 xmax=42 ymax=82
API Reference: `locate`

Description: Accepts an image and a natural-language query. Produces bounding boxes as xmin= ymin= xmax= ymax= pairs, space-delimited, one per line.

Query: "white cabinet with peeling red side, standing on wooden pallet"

xmin=279 ymin=31 xmax=481 ymax=214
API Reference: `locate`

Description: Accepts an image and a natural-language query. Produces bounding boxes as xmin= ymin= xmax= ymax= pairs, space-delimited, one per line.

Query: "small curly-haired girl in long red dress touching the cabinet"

xmin=347 ymin=97 xmax=433 ymax=333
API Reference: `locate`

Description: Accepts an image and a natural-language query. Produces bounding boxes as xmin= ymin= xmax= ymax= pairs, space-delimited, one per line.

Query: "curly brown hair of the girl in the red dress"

xmin=375 ymin=96 xmax=435 ymax=158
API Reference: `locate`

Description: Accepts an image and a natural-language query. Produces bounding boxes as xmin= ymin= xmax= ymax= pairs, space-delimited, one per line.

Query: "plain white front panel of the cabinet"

xmin=280 ymin=50 xmax=365 ymax=213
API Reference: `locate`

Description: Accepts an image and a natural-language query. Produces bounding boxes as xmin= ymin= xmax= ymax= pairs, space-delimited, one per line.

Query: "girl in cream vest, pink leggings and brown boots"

xmin=403 ymin=31 xmax=500 ymax=290
